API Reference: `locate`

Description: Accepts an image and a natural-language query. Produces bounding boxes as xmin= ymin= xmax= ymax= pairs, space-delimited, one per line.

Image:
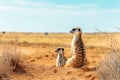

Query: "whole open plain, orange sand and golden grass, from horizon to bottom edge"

xmin=0 ymin=33 xmax=120 ymax=80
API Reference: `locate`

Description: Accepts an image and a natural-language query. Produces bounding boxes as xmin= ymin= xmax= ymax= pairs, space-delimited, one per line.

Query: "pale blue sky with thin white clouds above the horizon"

xmin=0 ymin=0 xmax=120 ymax=32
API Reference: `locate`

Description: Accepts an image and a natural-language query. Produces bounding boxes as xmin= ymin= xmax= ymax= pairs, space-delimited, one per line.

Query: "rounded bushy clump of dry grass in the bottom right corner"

xmin=97 ymin=52 xmax=120 ymax=80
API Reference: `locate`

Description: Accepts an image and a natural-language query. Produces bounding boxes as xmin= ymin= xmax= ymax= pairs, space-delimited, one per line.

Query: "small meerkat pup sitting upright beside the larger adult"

xmin=55 ymin=48 xmax=67 ymax=67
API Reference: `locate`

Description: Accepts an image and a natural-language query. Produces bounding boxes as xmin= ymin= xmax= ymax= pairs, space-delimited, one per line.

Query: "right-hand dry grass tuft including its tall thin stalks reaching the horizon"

xmin=97 ymin=29 xmax=120 ymax=80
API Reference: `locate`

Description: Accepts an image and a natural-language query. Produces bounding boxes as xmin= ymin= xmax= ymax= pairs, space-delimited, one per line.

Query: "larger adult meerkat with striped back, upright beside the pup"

xmin=65 ymin=27 xmax=87 ymax=68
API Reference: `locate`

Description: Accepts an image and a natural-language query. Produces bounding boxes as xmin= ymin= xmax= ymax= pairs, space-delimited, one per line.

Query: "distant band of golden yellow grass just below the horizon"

xmin=0 ymin=33 xmax=119 ymax=47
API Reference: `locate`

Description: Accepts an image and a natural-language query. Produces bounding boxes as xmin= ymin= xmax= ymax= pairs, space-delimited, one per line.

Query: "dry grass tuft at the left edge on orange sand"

xmin=0 ymin=47 xmax=20 ymax=78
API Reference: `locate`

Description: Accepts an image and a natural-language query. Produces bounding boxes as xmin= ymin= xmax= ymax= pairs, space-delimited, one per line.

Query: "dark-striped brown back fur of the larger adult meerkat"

xmin=72 ymin=37 xmax=86 ymax=68
